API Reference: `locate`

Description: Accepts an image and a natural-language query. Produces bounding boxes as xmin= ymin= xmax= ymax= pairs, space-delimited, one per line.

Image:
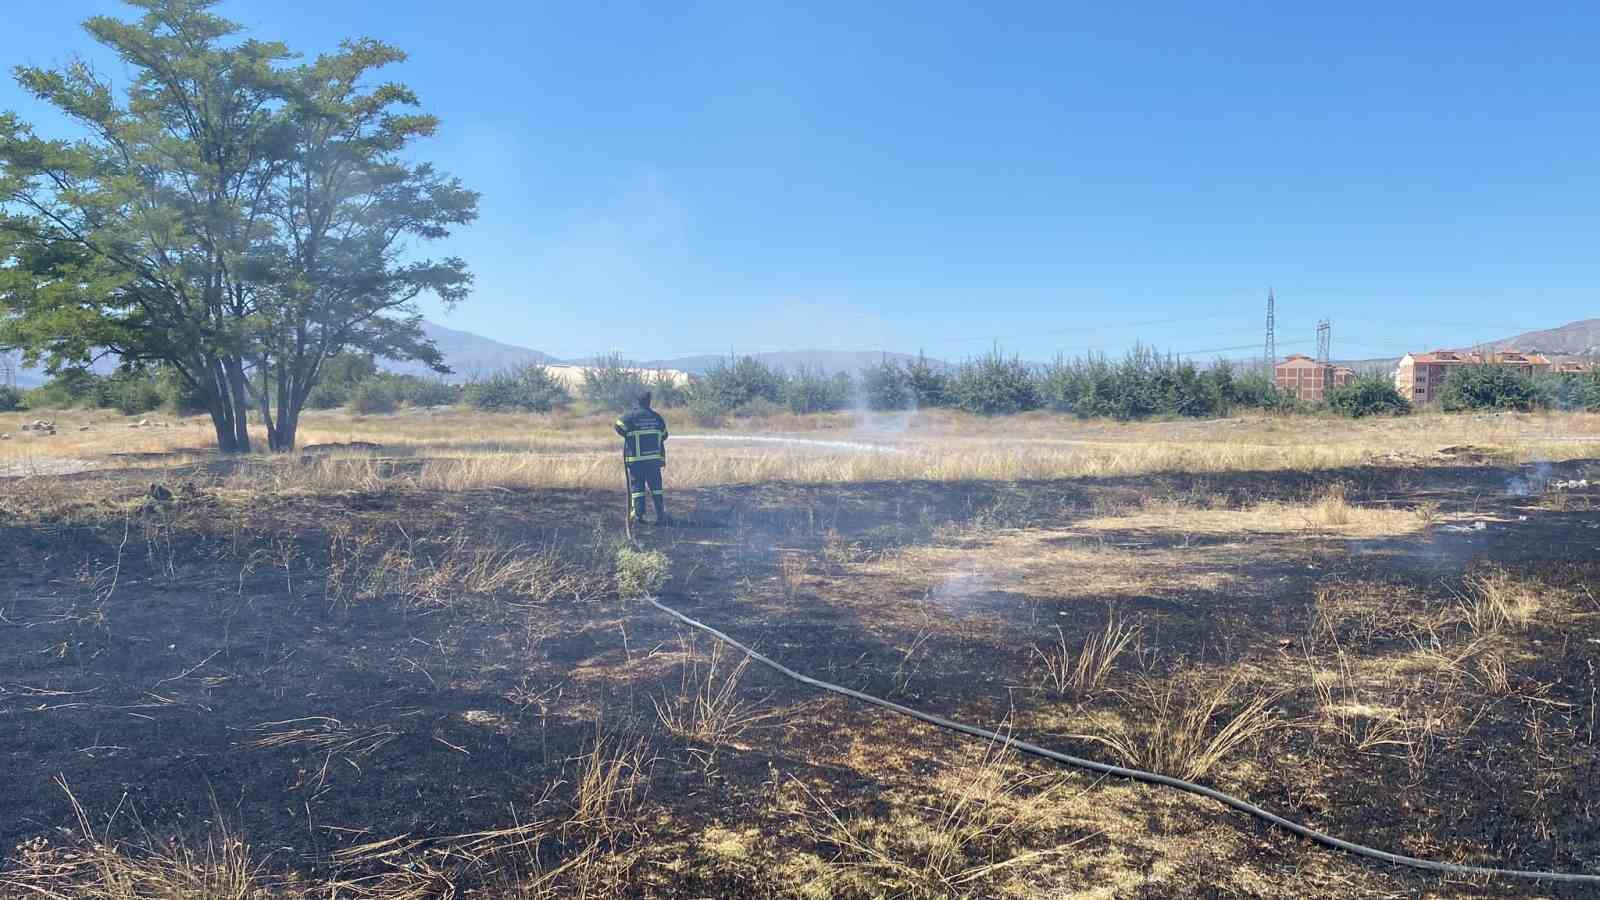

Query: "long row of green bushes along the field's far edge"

xmin=15 ymin=348 xmax=1600 ymax=424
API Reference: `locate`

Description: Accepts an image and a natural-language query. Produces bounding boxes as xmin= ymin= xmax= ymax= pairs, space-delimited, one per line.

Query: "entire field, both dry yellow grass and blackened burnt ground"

xmin=0 ymin=410 xmax=1600 ymax=900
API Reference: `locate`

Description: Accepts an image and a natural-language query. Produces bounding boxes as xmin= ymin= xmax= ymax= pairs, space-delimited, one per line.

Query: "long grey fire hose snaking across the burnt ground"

xmin=643 ymin=597 xmax=1600 ymax=887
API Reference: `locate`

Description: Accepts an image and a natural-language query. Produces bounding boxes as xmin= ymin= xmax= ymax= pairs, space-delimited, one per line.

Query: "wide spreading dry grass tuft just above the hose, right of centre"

xmin=1082 ymin=673 xmax=1283 ymax=780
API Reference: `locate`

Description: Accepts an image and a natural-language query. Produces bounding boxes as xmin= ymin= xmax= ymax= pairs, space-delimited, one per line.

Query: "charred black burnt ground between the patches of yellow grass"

xmin=0 ymin=463 xmax=1600 ymax=897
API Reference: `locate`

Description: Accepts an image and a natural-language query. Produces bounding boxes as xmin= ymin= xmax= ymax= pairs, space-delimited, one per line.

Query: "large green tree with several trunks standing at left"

xmin=0 ymin=0 xmax=477 ymax=452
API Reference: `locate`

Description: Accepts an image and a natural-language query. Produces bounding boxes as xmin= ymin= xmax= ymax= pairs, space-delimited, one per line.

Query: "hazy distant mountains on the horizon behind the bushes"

xmin=16 ymin=319 xmax=1600 ymax=388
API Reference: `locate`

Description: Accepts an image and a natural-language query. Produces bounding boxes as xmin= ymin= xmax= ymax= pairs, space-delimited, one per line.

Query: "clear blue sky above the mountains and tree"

xmin=0 ymin=0 xmax=1600 ymax=359
